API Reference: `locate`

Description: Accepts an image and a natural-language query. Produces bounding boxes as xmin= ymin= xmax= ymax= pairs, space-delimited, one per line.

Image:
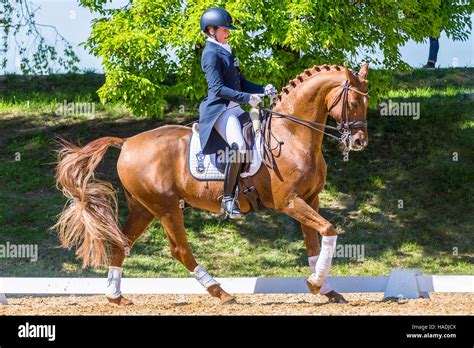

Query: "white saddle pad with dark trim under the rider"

xmin=188 ymin=123 xmax=262 ymax=181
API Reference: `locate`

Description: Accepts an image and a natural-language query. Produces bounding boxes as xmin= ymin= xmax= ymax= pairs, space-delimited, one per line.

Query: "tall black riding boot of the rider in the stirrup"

xmin=221 ymin=143 xmax=243 ymax=219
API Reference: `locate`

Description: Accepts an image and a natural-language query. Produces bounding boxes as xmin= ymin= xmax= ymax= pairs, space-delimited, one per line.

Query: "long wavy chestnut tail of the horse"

xmin=51 ymin=137 xmax=129 ymax=268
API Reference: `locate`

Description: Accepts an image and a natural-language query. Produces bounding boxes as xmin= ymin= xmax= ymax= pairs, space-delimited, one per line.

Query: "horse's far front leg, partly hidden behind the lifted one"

xmin=301 ymin=195 xmax=347 ymax=303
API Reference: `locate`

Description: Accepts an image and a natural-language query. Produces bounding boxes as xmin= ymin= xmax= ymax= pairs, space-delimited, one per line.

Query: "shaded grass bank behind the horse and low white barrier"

xmin=0 ymin=68 xmax=474 ymax=277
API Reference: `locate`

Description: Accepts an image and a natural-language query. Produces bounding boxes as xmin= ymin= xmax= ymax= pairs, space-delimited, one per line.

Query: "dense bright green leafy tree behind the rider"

xmin=81 ymin=0 xmax=473 ymax=115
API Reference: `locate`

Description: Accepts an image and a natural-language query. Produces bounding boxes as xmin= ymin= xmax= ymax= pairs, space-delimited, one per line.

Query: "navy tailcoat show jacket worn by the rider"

xmin=199 ymin=40 xmax=264 ymax=154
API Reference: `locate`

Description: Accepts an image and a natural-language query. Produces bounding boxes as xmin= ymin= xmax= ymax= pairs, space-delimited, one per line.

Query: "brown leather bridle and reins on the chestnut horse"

xmin=259 ymin=80 xmax=368 ymax=168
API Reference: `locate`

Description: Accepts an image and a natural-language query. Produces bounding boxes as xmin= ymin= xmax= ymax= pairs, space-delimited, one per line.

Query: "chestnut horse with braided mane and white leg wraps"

xmin=53 ymin=64 xmax=368 ymax=305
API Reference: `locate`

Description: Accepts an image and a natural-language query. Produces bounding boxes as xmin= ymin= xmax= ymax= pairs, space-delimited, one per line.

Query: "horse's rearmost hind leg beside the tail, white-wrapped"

xmin=106 ymin=191 xmax=154 ymax=305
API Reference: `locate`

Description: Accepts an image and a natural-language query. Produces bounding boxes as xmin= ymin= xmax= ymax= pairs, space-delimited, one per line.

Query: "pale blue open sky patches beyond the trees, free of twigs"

xmin=2 ymin=0 xmax=474 ymax=72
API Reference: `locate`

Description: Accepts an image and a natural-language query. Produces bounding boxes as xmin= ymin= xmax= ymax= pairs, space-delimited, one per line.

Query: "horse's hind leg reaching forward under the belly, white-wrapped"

xmin=159 ymin=207 xmax=235 ymax=304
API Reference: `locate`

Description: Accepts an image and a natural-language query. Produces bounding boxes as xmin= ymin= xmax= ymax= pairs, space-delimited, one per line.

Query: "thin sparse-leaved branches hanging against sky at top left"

xmin=0 ymin=0 xmax=79 ymax=74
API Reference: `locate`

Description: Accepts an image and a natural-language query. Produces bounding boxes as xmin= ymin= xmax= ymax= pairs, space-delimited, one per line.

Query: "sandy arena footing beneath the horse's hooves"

xmin=0 ymin=293 xmax=474 ymax=315
